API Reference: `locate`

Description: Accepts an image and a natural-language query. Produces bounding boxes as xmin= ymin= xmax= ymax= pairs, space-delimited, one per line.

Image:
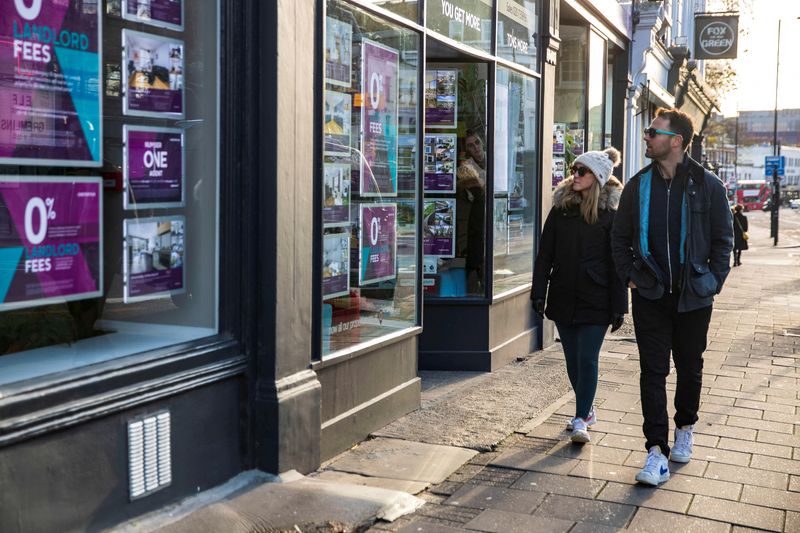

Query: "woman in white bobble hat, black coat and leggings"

xmin=531 ymin=148 xmax=628 ymax=443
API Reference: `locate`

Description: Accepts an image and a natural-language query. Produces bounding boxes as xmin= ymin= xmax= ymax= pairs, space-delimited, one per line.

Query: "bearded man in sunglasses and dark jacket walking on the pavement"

xmin=611 ymin=108 xmax=733 ymax=486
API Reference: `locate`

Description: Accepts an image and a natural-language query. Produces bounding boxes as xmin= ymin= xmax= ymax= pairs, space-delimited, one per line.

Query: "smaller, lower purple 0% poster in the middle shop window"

xmin=358 ymin=204 xmax=397 ymax=285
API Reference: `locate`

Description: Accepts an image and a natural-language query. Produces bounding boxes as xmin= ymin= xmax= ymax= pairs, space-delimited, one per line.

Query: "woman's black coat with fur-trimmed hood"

xmin=531 ymin=176 xmax=628 ymax=325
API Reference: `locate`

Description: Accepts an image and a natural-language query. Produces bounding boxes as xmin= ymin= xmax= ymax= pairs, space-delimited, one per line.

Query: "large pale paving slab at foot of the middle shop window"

xmin=328 ymin=439 xmax=478 ymax=483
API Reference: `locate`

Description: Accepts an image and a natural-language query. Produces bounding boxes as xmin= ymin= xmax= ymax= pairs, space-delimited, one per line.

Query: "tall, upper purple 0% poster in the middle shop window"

xmin=359 ymin=39 xmax=399 ymax=196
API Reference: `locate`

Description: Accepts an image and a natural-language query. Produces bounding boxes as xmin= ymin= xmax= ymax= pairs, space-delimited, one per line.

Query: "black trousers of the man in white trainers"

xmin=632 ymin=289 xmax=712 ymax=455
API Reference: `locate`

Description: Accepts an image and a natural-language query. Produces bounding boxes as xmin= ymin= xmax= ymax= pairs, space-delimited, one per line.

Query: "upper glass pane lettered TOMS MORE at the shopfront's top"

xmin=497 ymin=0 xmax=539 ymax=70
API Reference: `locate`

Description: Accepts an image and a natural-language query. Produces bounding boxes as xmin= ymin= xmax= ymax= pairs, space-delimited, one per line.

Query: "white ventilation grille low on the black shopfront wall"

xmin=128 ymin=411 xmax=172 ymax=500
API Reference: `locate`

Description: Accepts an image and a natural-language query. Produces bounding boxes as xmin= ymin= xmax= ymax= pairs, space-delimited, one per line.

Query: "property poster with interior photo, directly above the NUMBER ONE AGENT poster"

xmin=122 ymin=30 xmax=184 ymax=118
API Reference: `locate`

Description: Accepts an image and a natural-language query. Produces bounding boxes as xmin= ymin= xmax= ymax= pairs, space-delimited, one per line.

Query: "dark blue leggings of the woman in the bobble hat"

xmin=556 ymin=322 xmax=608 ymax=418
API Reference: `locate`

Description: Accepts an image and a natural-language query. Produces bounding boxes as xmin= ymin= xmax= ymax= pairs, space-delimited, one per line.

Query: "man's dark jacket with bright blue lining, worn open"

xmin=611 ymin=156 xmax=733 ymax=313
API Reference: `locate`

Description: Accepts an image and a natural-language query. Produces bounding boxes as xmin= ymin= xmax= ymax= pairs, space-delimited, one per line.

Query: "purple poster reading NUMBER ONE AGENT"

xmin=122 ymin=125 xmax=185 ymax=209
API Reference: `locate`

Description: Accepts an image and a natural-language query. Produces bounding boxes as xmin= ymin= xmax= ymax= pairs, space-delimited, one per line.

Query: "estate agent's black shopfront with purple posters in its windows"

xmin=0 ymin=0 xmax=620 ymax=532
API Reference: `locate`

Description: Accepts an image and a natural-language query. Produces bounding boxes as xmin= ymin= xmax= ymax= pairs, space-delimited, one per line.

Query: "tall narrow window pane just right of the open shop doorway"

xmin=493 ymin=68 xmax=538 ymax=297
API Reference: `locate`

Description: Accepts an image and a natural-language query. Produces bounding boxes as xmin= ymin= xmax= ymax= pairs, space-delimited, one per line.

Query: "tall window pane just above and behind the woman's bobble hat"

xmin=551 ymin=25 xmax=588 ymax=187
